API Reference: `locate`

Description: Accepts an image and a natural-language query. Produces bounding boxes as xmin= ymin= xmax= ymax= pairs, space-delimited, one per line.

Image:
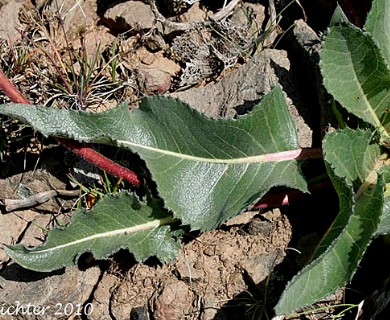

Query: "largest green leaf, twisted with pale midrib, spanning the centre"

xmin=0 ymin=87 xmax=306 ymax=230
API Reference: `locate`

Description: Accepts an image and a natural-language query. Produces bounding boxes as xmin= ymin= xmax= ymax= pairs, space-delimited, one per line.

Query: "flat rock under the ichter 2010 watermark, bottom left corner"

xmin=0 ymin=264 xmax=100 ymax=320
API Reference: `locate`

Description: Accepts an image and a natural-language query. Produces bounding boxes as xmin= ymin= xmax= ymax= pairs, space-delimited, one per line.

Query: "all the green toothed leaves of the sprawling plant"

xmin=0 ymin=0 xmax=390 ymax=315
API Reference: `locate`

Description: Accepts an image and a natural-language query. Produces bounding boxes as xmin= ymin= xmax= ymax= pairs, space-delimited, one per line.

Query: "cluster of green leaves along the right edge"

xmin=275 ymin=0 xmax=390 ymax=315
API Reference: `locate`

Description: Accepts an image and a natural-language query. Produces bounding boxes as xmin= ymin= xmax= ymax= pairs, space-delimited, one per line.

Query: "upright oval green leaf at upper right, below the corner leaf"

xmin=320 ymin=24 xmax=390 ymax=136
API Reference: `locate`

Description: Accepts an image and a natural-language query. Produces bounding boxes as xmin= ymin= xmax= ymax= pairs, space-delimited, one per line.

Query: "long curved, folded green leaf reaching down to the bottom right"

xmin=276 ymin=129 xmax=385 ymax=315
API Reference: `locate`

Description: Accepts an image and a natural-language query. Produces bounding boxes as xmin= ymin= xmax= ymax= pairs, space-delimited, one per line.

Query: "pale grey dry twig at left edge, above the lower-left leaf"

xmin=2 ymin=190 xmax=80 ymax=212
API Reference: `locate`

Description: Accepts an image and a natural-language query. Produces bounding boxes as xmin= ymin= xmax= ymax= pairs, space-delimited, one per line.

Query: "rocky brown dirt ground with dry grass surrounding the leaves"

xmin=0 ymin=0 xmax=372 ymax=320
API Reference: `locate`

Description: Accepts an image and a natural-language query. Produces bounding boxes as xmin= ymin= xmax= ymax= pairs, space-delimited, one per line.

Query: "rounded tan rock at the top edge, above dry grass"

xmin=103 ymin=1 xmax=155 ymax=32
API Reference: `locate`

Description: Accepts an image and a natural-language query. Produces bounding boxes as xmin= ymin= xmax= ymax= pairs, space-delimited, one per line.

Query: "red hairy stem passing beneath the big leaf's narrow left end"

xmin=0 ymin=70 xmax=141 ymax=187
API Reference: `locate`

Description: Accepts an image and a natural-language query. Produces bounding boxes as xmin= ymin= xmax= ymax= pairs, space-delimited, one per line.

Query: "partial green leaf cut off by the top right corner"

xmin=364 ymin=0 xmax=390 ymax=66
